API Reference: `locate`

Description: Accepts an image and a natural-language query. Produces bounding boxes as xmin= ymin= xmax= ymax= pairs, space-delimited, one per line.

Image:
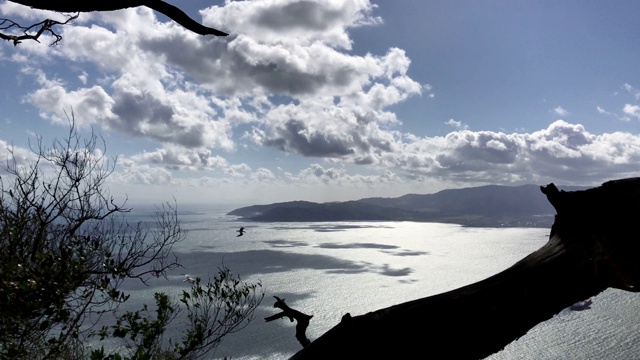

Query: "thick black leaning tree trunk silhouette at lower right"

xmin=291 ymin=178 xmax=640 ymax=360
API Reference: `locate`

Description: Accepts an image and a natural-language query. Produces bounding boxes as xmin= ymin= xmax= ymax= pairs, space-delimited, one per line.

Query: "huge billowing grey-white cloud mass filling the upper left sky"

xmin=13 ymin=0 xmax=420 ymax=163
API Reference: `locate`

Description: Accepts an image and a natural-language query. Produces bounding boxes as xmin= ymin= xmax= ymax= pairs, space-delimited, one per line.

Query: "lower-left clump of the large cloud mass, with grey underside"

xmin=25 ymin=72 xmax=234 ymax=150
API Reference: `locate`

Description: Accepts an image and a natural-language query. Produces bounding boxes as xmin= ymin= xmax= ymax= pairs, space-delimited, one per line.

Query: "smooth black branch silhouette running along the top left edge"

xmin=12 ymin=0 xmax=228 ymax=36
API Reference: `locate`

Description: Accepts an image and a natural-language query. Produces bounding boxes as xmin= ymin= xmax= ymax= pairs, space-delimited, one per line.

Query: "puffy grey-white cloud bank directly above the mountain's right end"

xmin=380 ymin=120 xmax=640 ymax=183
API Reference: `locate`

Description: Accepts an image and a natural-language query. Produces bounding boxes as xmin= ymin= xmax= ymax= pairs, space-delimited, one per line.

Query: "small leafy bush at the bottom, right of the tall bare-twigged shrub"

xmin=94 ymin=267 xmax=264 ymax=359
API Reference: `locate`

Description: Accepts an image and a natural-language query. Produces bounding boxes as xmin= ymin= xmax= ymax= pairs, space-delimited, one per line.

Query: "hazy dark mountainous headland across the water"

xmin=229 ymin=185 xmax=586 ymax=227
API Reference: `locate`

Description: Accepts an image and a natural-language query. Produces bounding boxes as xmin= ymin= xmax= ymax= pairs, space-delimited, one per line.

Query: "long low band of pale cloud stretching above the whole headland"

xmin=100 ymin=120 xmax=640 ymax=203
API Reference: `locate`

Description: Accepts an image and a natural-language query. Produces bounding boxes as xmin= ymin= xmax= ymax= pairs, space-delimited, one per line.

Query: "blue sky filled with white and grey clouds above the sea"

xmin=0 ymin=0 xmax=640 ymax=205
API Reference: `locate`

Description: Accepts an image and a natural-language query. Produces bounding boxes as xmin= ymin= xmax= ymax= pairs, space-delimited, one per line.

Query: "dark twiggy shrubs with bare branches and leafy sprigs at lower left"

xmin=0 ymin=122 xmax=263 ymax=359
